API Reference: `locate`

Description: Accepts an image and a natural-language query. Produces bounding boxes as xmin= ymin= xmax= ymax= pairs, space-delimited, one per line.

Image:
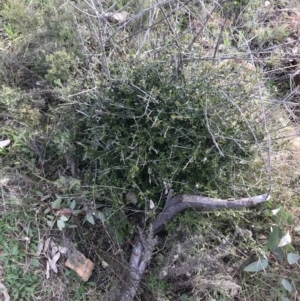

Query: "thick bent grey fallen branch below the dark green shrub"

xmin=119 ymin=192 xmax=269 ymax=301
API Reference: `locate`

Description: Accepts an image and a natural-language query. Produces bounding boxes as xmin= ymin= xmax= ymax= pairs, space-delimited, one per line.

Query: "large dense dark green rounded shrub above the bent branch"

xmin=51 ymin=62 xmax=255 ymax=203
